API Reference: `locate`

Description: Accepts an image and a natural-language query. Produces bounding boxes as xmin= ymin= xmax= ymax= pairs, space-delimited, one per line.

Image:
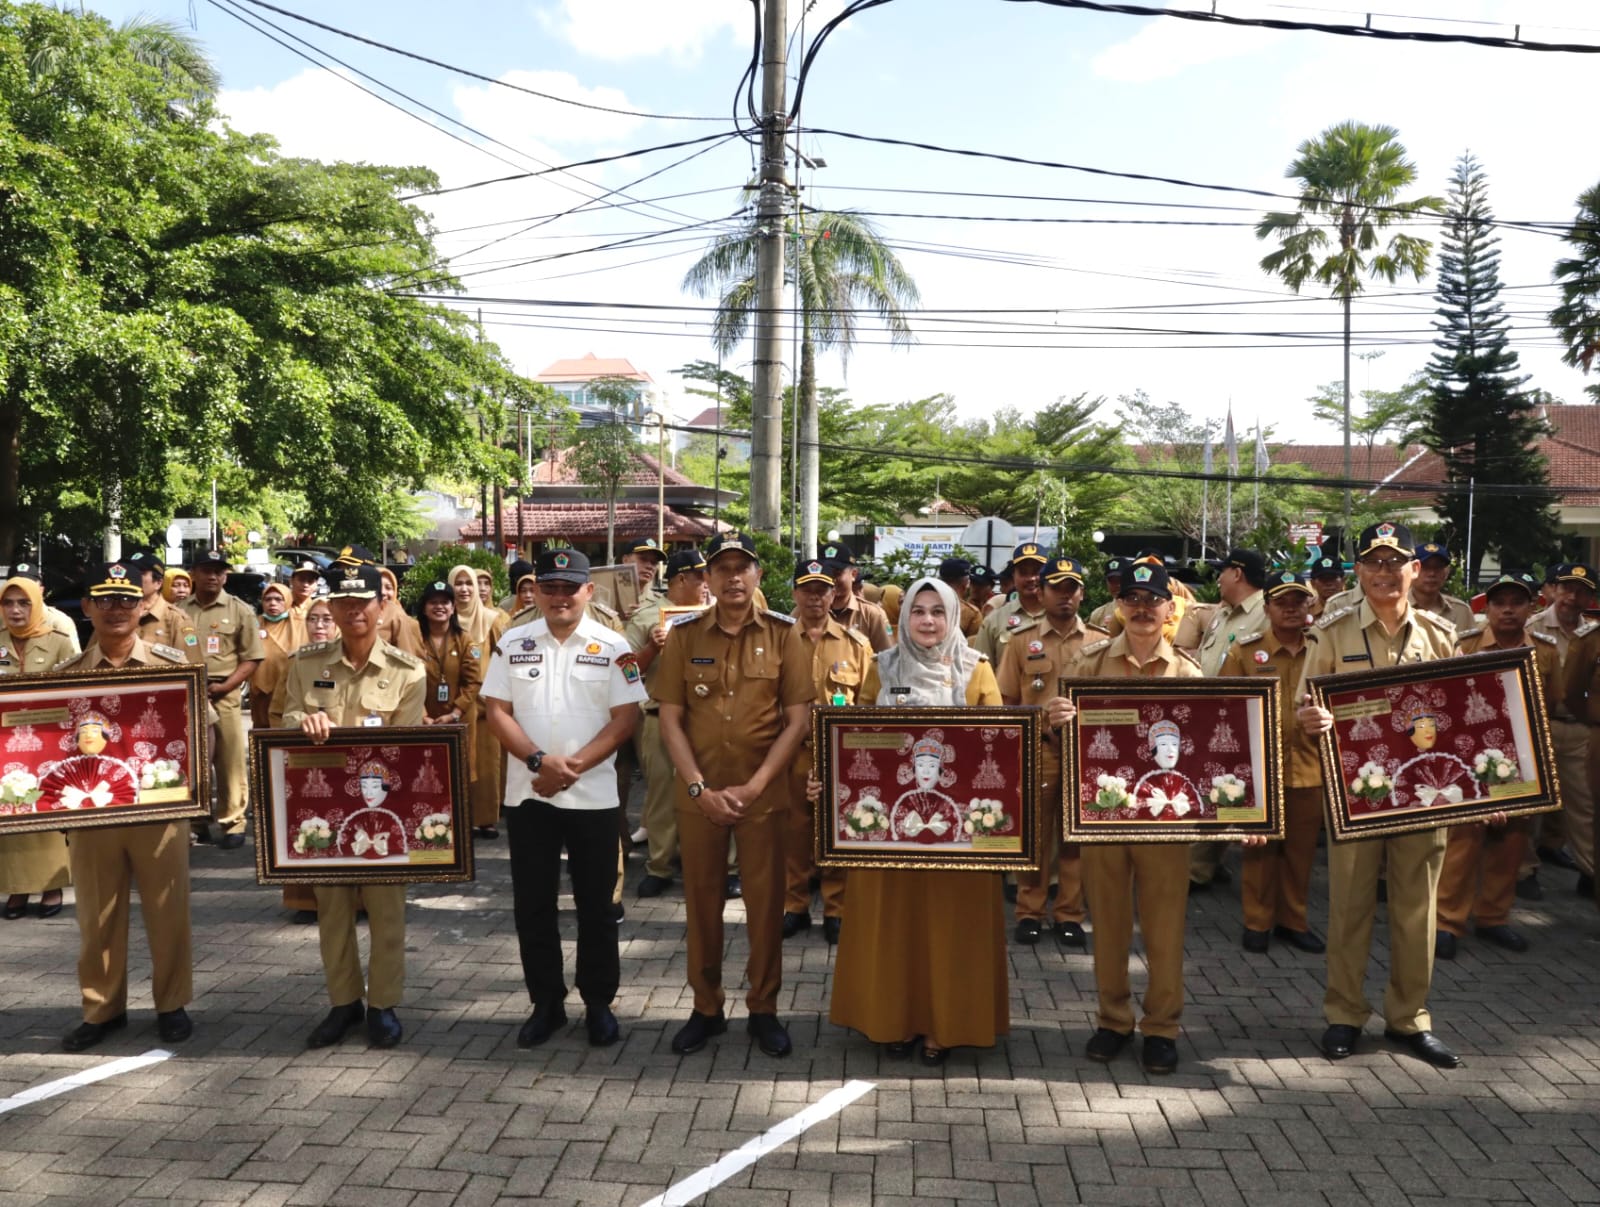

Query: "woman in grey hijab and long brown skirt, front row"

xmin=808 ymin=578 xmax=1011 ymax=1065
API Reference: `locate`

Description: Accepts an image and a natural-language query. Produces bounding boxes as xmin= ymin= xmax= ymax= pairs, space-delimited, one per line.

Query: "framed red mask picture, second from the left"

xmin=250 ymin=725 xmax=472 ymax=884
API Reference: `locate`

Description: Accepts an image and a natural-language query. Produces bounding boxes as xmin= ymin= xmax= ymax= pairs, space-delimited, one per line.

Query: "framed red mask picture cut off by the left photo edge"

xmin=0 ymin=664 xmax=211 ymax=834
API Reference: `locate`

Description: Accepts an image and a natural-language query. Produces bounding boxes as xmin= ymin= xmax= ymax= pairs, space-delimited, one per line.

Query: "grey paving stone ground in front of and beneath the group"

xmin=0 ymin=793 xmax=1600 ymax=1207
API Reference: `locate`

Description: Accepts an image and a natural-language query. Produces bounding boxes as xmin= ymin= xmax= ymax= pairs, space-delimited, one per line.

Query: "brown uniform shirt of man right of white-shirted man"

xmin=654 ymin=607 xmax=816 ymax=791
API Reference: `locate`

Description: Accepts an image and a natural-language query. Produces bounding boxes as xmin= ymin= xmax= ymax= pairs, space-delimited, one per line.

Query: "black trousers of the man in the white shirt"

xmin=501 ymin=800 xmax=622 ymax=1007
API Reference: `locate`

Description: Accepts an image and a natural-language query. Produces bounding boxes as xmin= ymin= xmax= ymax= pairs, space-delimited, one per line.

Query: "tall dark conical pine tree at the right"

xmin=1424 ymin=152 xmax=1557 ymax=583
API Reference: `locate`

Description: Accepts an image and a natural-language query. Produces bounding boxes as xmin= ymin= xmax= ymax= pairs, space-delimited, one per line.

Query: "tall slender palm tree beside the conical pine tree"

xmin=1256 ymin=122 xmax=1445 ymax=553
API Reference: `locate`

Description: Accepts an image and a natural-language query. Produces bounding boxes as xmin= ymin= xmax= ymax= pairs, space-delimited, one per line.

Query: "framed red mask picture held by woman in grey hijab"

xmin=811 ymin=708 xmax=1040 ymax=871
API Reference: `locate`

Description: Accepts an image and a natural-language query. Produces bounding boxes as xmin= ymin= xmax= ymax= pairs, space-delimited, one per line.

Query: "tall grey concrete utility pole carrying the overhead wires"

xmin=750 ymin=0 xmax=789 ymax=539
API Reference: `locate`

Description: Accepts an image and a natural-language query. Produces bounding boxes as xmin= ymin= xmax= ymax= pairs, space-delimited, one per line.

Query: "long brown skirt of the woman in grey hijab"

xmin=829 ymin=868 xmax=1011 ymax=1049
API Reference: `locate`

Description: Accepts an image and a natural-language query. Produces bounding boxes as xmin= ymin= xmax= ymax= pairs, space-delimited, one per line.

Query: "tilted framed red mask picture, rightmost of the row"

xmin=1310 ymin=647 xmax=1560 ymax=840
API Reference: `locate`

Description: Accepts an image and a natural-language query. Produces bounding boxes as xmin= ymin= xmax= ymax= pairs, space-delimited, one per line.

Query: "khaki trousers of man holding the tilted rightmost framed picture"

xmin=1322 ymin=829 xmax=1446 ymax=1036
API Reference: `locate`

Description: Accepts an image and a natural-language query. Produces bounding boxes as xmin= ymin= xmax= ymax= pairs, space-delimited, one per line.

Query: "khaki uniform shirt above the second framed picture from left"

xmin=283 ymin=637 xmax=427 ymax=728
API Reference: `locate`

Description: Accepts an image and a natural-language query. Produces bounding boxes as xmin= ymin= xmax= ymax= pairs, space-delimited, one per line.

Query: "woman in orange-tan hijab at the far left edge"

xmin=0 ymin=575 xmax=77 ymax=919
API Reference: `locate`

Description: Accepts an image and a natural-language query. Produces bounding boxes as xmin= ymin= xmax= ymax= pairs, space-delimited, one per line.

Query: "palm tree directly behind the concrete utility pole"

xmin=683 ymin=211 xmax=920 ymax=549
